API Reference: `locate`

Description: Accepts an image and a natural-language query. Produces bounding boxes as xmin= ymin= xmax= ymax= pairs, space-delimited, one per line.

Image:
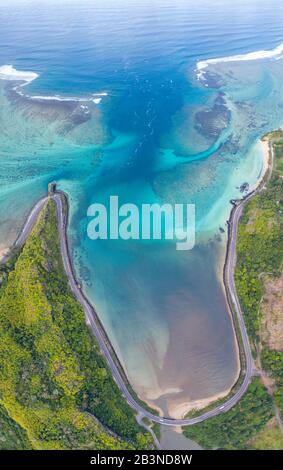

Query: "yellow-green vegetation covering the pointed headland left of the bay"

xmin=0 ymin=200 xmax=152 ymax=449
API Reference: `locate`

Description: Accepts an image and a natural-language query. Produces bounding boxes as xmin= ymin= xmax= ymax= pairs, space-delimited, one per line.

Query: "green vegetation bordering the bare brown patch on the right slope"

xmin=235 ymin=131 xmax=283 ymax=413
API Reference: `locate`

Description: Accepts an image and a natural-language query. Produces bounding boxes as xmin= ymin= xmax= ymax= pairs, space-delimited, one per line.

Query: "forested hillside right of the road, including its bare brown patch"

xmin=235 ymin=131 xmax=283 ymax=416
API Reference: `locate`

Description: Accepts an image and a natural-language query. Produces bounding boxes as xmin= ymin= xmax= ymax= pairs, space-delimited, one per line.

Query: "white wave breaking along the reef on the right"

xmin=197 ymin=43 xmax=283 ymax=78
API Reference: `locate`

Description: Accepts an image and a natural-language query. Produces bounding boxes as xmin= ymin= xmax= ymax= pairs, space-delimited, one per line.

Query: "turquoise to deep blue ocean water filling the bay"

xmin=0 ymin=0 xmax=283 ymax=415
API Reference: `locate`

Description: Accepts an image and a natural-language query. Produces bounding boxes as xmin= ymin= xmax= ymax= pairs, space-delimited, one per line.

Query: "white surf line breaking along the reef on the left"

xmin=0 ymin=65 xmax=108 ymax=104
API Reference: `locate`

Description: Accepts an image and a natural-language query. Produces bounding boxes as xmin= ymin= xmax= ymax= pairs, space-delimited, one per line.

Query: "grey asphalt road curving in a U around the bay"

xmin=11 ymin=186 xmax=262 ymax=426
